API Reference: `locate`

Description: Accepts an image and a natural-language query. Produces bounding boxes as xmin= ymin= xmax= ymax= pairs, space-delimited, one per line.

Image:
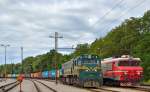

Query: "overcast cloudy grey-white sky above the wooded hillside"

xmin=0 ymin=0 xmax=150 ymax=64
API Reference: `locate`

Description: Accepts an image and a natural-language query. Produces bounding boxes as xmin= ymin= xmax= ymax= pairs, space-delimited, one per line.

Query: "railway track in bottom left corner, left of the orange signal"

xmin=0 ymin=81 xmax=19 ymax=92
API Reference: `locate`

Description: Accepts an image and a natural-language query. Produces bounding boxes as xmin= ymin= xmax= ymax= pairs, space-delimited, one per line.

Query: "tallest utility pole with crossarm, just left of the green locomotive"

xmin=49 ymin=32 xmax=63 ymax=84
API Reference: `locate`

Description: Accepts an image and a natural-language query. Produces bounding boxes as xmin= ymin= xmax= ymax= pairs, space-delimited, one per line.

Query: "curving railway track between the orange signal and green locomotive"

xmin=31 ymin=80 xmax=57 ymax=92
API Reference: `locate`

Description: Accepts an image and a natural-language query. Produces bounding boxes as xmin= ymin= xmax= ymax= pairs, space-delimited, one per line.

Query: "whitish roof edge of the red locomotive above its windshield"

xmin=102 ymin=58 xmax=141 ymax=63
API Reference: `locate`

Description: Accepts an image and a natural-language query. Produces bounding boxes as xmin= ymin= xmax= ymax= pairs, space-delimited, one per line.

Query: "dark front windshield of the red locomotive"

xmin=118 ymin=60 xmax=139 ymax=66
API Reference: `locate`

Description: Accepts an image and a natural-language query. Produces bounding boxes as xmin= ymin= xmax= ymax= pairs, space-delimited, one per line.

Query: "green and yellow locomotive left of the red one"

xmin=62 ymin=55 xmax=102 ymax=87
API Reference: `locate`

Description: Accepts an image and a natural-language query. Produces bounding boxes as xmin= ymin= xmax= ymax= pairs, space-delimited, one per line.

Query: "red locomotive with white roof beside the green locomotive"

xmin=102 ymin=55 xmax=143 ymax=86
